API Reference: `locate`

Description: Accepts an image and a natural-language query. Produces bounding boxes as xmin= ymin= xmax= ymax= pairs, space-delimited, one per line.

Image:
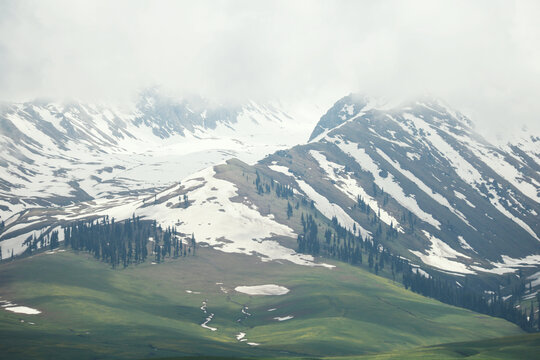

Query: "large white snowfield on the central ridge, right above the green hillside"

xmin=135 ymin=168 xmax=332 ymax=266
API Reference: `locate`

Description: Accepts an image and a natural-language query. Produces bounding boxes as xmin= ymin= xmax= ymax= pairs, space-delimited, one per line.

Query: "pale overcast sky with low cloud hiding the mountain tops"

xmin=0 ymin=0 xmax=540 ymax=139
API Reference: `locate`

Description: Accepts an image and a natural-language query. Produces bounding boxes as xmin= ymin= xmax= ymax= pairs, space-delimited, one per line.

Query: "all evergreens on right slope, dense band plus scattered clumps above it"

xmin=251 ymin=168 xmax=540 ymax=331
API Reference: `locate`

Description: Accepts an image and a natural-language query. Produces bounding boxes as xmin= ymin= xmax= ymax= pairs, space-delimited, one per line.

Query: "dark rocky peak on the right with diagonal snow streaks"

xmin=266 ymin=95 xmax=540 ymax=274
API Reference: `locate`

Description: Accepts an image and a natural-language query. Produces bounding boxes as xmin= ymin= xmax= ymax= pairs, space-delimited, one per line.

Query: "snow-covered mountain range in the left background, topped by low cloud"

xmin=0 ymin=89 xmax=317 ymax=220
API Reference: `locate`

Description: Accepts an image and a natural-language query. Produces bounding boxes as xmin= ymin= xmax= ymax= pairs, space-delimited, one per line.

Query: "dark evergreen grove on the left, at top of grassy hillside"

xmin=64 ymin=216 xmax=197 ymax=268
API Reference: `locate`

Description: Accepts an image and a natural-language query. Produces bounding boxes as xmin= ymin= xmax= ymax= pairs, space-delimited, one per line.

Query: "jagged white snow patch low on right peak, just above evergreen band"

xmin=409 ymin=230 xmax=476 ymax=274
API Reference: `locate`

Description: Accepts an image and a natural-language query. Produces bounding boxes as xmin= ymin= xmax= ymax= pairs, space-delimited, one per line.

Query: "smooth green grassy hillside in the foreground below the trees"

xmin=0 ymin=248 xmax=521 ymax=359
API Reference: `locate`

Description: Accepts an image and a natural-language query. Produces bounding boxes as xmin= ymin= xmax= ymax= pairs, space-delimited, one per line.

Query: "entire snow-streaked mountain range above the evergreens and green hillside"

xmin=0 ymin=92 xmax=540 ymax=285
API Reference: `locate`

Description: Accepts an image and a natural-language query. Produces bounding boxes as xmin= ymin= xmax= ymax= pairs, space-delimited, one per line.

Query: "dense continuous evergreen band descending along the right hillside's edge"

xmin=298 ymin=210 xmax=540 ymax=331
